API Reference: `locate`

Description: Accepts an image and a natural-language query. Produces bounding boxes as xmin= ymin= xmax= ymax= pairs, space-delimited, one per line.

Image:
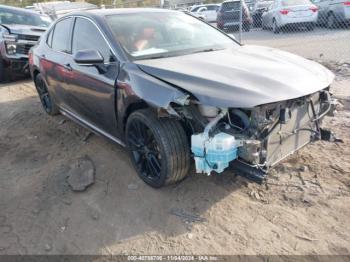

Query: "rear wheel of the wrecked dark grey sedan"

xmin=34 ymin=74 xmax=59 ymax=116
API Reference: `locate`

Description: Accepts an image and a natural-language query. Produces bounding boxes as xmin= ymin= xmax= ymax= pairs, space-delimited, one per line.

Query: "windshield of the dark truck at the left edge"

xmin=0 ymin=9 xmax=51 ymax=27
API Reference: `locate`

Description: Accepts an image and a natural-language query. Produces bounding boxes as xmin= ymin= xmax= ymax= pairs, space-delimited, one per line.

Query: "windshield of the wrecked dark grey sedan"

xmin=106 ymin=12 xmax=238 ymax=59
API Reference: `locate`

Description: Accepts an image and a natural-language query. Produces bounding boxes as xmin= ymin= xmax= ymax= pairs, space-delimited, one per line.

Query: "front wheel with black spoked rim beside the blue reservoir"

xmin=125 ymin=109 xmax=190 ymax=188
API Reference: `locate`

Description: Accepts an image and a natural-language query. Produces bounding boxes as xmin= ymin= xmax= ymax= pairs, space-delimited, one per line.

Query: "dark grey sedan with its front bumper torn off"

xmin=30 ymin=9 xmax=334 ymax=187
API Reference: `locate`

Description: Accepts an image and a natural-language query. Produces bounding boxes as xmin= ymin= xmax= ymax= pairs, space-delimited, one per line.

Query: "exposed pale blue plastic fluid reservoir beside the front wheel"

xmin=191 ymin=132 xmax=237 ymax=175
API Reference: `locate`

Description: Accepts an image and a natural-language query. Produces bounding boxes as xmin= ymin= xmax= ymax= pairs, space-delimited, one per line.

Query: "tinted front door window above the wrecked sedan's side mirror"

xmin=73 ymin=18 xmax=113 ymax=63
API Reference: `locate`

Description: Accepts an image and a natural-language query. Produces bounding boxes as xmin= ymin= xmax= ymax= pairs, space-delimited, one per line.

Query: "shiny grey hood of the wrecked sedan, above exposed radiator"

xmin=135 ymin=45 xmax=334 ymax=108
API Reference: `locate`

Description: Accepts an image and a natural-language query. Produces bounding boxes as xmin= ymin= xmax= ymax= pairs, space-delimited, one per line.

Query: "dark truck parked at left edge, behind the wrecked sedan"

xmin=0 ymin=5 xmax=51 ymax=82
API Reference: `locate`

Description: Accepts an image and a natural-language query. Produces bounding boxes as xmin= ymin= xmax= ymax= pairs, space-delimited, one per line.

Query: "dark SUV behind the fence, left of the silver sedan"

xmin=217 ymin=0 xmax=253 ymax=31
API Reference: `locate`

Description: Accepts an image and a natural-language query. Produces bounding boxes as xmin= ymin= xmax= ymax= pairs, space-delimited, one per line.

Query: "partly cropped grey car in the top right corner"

xmin=313 ymin=0 xmax=350 ymax=28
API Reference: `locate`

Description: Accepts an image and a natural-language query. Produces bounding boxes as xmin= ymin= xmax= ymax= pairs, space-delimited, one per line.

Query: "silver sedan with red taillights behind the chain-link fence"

xmin=262 ymin=0 xmax=318 ymax=34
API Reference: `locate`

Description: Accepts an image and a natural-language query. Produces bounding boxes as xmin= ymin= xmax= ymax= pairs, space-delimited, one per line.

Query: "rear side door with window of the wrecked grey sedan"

xmin=39 ymin=18 xmax=73 ymax=106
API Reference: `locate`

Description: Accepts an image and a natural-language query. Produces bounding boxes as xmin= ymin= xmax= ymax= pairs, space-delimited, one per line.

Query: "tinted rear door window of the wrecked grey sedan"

xmin=52 ymin=18 xmax=72 ymax=53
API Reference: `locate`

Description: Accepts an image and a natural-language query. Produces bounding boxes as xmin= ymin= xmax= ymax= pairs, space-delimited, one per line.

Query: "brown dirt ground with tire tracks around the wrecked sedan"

xmin=0 ymin=64 xmax=350 ymax=254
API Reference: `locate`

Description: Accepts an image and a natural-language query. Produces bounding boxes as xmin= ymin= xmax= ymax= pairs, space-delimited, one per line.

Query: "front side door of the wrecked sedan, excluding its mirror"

xmin=62 ymin=17 xmax=119 ymax=136
